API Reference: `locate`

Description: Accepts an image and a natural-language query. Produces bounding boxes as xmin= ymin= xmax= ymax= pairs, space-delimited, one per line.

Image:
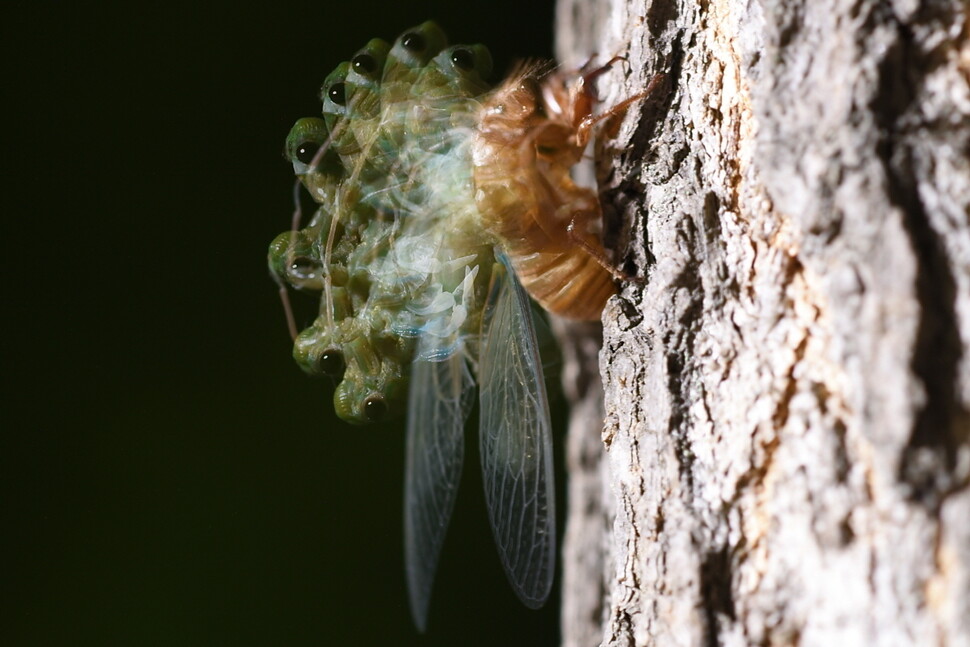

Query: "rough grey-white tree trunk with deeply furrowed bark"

xmin=557 ymin=0 xmax=970 ymax=647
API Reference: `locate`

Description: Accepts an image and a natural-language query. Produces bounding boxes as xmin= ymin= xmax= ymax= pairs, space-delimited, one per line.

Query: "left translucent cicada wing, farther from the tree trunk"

xmin=404 ymin=350 xmax=475 ymax=631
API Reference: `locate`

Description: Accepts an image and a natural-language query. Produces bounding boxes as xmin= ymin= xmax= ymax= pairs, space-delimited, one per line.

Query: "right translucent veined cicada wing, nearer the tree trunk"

xmin=478 ymin=255 xmax=556 ymax=609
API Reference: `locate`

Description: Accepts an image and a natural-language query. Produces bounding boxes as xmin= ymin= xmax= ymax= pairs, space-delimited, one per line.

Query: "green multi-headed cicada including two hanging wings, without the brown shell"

xmin=269 ymin=22 xmax=555 ymax=629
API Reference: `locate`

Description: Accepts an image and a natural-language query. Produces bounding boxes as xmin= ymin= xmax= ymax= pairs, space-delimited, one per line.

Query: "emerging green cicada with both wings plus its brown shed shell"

xmin=269 ymin=22 xmax=640 ymax=630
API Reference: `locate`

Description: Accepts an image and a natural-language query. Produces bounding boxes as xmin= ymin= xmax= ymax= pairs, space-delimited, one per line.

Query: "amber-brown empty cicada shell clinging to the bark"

xmin=472 ymin=65 xmax=616 ymax=320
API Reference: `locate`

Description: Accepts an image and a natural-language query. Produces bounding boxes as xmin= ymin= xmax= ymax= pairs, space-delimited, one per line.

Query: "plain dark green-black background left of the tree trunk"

xmin=7 ymin=0 xmax=562 ymax=646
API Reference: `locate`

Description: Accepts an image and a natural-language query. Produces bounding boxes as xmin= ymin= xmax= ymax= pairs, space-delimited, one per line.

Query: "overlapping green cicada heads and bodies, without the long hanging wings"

xmin=270 ymin=22 xmax=494 ymax=423
